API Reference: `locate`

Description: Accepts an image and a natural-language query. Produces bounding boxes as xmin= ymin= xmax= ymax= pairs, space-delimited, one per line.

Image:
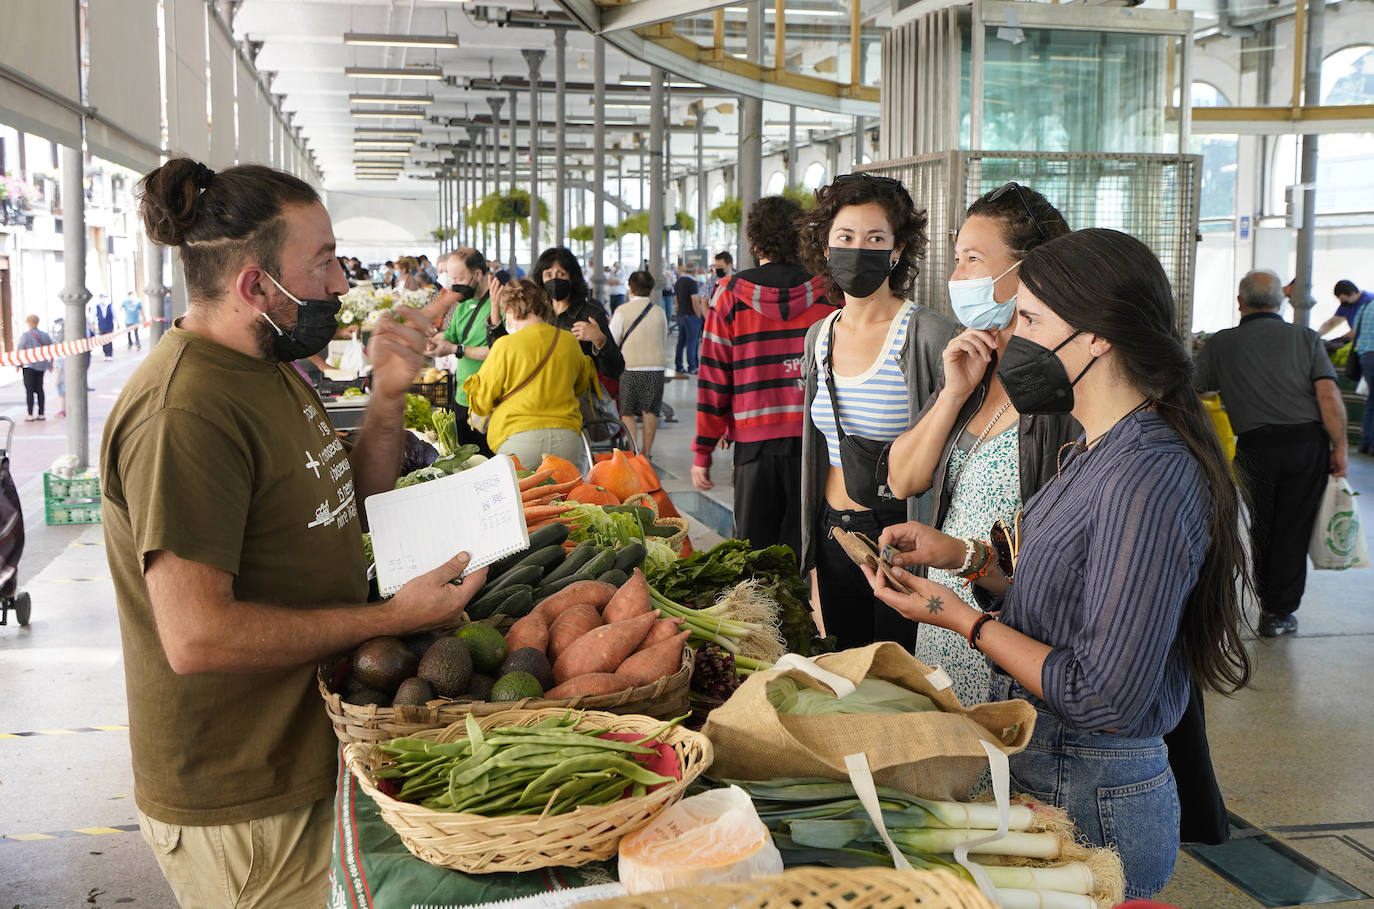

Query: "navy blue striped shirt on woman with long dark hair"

xmin=1000 ymin=412 xmax=1212 ymax=736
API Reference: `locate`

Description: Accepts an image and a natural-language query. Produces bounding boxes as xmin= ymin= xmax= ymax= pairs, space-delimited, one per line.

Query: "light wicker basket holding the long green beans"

xmin=344 ymin=709 xmax=712 ymax=873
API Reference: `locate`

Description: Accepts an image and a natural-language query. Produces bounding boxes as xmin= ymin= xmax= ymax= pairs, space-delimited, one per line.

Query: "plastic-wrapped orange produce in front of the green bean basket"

xmin=620 ymin=785 xmax=782 ymax=894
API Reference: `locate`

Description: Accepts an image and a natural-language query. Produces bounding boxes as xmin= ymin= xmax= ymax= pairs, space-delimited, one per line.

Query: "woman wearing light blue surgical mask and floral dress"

xmin=888 ymin=183 xmax=1081 ymax=704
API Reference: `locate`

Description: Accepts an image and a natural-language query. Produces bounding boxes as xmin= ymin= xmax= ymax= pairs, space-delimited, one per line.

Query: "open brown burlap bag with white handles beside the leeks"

xmin=702 ymin=643 xmax=1036 ymax=799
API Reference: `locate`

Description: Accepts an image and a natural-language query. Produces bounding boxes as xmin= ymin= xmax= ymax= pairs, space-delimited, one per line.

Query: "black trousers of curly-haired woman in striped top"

xmin=816 ymin=505 xmax=916 ymax=651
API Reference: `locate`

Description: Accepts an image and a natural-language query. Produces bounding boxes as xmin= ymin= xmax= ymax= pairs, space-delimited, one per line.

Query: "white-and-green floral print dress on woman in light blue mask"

xmin=915 ymin=426 xmax=1021 ymax=707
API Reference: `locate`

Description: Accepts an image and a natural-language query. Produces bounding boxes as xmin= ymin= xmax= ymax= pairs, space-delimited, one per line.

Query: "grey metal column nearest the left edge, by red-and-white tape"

xmin=59 ymin=146 xmax=91 ymax=470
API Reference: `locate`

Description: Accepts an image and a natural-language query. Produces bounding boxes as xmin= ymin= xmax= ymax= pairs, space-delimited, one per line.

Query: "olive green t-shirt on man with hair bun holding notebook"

xmin=100 ymin=328 xmax=367 ymax=825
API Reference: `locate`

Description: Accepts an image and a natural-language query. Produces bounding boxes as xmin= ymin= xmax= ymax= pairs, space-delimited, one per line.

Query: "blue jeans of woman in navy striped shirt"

xmin=991 ymin=671 xmax=1179 ymax=899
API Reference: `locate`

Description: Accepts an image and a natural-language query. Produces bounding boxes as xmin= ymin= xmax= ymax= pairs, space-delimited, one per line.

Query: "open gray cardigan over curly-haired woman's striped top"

xmin=800 ymin=303 xmax=959 ymax=574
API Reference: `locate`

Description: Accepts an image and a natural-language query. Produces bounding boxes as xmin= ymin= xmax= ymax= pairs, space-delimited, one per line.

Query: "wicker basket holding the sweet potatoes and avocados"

xmin=316 ymin=648 xmax=692 ymax=744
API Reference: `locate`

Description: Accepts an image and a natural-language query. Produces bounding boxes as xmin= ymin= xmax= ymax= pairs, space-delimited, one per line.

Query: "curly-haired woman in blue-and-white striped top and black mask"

xmin=800 ymin=173 xmax=956 ymax=651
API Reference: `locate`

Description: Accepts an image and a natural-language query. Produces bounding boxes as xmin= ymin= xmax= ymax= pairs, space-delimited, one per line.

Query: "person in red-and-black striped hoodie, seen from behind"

xmin=691 ymin=196 xmax=835 ymax=553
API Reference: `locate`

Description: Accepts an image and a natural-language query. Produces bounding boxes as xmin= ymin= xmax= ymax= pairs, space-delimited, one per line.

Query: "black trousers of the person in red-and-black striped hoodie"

xmin=735 ymin=438 xmax=801 ymax=562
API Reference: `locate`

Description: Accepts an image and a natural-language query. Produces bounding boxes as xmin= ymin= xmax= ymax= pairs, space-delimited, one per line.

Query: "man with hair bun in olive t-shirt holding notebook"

xmin=100 ymin=158 xmax=485 ymax=906
